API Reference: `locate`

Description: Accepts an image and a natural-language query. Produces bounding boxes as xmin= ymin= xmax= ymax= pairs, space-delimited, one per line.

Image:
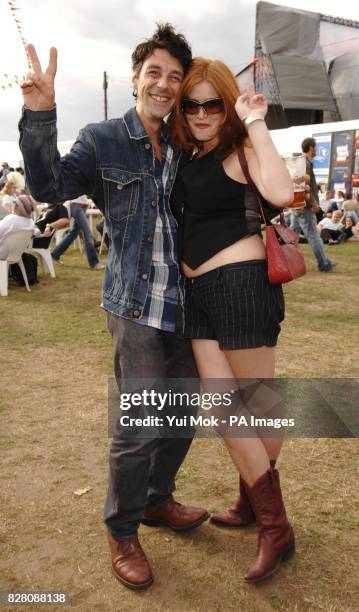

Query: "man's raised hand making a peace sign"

xmin=20 ymin=45 xmax=57 ymax=111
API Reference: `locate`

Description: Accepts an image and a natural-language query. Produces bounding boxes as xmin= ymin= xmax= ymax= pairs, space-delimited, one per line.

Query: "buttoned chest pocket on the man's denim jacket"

xmin=102 ymin=168 xmax=142 ymax=221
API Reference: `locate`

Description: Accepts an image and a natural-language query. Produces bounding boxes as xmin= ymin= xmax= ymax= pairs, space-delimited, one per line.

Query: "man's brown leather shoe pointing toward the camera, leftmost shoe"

xmin=108 ymin=532 xmax=153 ymax=590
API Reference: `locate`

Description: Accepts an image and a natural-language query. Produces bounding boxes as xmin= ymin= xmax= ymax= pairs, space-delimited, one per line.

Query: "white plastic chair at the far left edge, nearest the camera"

xmin=0 ymin=229 xmax=33 ymax=297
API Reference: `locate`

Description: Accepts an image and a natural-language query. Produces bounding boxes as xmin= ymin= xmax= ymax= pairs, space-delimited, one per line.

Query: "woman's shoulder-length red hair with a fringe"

xmin=169 ymin=57 xmax=248 ymax=155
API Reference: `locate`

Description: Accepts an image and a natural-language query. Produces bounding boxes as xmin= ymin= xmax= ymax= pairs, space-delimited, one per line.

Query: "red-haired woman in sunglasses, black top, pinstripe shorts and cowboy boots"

xmin=172 ymin=58 xmax=294 ymax=582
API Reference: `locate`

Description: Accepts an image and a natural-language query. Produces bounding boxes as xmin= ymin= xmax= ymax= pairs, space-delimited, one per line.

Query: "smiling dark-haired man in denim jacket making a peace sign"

xmin=20 ymin=24 xmax=208 ymax=589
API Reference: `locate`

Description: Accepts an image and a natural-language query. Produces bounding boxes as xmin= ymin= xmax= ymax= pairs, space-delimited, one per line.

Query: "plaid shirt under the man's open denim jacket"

xmin=136 ymin=144 xmax=179 ymax=332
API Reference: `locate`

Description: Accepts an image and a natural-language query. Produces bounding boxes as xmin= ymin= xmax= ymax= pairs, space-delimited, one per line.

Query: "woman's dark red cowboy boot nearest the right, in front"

xmin=245 ymin=469 xmax=295 ymax=582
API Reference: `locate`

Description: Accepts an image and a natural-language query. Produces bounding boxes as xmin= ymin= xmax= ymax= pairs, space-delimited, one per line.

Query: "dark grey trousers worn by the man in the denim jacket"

xmin=104 ymin=312 xmax=199 ymax=540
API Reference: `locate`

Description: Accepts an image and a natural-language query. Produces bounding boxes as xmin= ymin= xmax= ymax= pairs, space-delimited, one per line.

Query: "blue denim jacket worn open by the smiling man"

xmin=19 ymin=108 xmax=181 ymax=319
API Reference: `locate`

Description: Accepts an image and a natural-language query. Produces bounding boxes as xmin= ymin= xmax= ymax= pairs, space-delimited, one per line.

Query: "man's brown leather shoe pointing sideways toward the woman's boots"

xmin=142 ymin=500 xmax=209 ymax=531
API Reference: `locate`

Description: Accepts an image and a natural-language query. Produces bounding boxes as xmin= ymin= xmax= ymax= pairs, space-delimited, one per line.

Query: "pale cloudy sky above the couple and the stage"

xmin=0 ymin=0 xmax=359 ymax=141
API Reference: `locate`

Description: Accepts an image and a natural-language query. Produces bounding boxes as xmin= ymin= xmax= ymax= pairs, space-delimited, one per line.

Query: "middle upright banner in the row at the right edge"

xmin=330 ymin=130 xmax=354 ymax=192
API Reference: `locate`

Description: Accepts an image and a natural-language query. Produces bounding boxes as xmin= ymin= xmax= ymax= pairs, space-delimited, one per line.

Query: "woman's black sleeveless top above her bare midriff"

xmin=172 ymin=149 xmax=261 ymax=270
